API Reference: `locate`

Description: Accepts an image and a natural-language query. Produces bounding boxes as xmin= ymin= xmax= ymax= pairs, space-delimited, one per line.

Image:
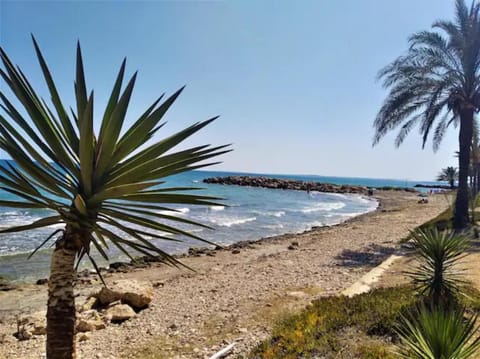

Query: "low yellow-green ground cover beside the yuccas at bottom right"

xmin=248 ymin=285 xmax=480 ymax=359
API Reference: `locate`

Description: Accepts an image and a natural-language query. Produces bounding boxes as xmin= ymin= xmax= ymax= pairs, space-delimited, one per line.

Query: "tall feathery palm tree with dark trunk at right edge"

xmin=373 ymin=0 xmax=480 ymax=230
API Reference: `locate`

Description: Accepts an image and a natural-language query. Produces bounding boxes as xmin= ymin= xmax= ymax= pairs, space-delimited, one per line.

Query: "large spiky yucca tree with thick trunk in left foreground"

xmin=0 ymin=39 xmax=228 ymax=359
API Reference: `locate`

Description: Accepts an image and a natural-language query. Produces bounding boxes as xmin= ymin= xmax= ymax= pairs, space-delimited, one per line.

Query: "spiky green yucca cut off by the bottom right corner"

xmin=396 ymin=307 xmax=480 ymax=359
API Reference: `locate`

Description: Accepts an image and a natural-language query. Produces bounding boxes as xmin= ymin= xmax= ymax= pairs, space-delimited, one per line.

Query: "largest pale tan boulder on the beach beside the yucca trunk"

xmin=97 ymin=279 xmax=153 ymax=309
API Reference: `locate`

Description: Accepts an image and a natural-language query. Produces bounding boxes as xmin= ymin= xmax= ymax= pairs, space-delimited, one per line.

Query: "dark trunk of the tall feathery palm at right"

xmin=453 ymin=108 xmax=473 ymax=231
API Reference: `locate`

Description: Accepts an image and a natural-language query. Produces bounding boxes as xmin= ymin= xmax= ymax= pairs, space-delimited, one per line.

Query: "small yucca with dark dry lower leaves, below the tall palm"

xmin=407 ymin=228 xmax=470 ymax=305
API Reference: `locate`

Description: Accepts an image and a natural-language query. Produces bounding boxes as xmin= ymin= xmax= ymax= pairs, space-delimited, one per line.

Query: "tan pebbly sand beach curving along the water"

xmin=0 ymin=191 xmax=449 ymax=359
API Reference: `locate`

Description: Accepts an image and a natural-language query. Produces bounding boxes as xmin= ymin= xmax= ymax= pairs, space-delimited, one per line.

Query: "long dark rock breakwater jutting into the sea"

xmin=203 ymin=176 xmax=416 ymax=195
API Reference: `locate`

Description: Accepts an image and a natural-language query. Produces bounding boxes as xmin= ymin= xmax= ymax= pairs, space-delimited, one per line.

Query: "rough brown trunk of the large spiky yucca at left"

xmin=47 ymin=228 xmax=81 ymax=359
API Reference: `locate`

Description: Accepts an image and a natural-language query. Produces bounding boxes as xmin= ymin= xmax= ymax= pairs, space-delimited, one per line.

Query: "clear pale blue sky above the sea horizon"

xmin=0 ymin=0 xmax=457 ymax=180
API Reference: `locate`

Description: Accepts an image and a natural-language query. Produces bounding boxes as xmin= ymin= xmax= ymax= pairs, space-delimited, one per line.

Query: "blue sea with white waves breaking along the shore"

xmin=0 ymin=171 xmax=437 ymax=282
